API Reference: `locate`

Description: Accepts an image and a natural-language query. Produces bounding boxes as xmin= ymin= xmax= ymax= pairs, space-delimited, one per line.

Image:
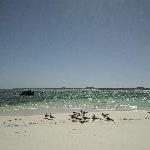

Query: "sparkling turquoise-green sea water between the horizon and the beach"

xmin=0 ymin=89 xmax=150 ymax=110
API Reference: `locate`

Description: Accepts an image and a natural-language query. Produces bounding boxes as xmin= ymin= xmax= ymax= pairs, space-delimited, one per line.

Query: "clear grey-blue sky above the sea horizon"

xmin=0 ymin=0 xmax=150 ymax=88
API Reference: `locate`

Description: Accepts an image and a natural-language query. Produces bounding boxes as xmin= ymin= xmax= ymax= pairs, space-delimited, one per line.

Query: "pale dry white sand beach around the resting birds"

xmin=0 ymin=111 xmax=150 ymax=150
